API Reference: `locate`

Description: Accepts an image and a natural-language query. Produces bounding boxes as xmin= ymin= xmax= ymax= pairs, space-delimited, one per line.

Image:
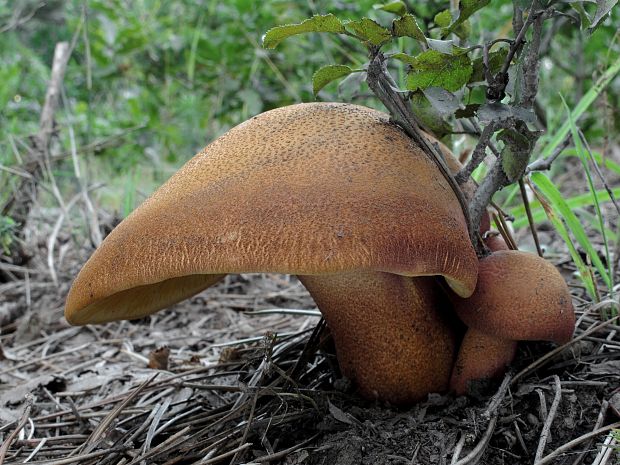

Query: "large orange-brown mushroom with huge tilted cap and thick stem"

xmin=65 ymin=103 xmax=478 ymax=403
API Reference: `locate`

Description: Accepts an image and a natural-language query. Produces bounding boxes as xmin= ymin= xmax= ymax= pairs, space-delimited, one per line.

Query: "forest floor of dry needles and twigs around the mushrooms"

xmin=0 ymin=223 xmax=620 ymax=465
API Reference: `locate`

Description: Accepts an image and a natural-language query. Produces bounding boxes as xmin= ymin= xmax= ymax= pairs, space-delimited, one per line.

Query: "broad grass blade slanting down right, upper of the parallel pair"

xmin=530 ymin=172 xmax=612 ymax=288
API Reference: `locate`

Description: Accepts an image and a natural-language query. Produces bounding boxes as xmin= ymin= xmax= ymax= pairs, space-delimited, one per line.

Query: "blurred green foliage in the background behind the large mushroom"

xmin=0 ymin=0 xmax=620 ymax=214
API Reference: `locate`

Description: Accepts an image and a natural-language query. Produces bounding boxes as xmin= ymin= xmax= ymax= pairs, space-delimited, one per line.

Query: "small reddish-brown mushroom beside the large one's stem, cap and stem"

xmin=450 ymin=250 xmax=575 ymax=394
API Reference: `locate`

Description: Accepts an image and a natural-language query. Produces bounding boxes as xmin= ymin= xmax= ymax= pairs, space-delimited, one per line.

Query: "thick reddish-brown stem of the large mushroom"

xmin=299 ymin=271 xmax=456 ymax=404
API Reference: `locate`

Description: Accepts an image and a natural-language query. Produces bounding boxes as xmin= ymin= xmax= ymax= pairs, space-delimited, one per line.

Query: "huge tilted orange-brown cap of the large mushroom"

xmin=65 ymin=103 xmax=477 ymax=324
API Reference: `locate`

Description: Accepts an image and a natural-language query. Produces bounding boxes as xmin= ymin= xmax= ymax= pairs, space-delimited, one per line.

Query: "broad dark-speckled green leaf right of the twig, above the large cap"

xmin=407 ymin=50 xmax=473 ymax=92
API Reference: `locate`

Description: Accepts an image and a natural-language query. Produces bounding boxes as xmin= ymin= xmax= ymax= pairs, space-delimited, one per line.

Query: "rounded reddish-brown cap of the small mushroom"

xmin=454 ymin=250 xmax=575 ymax=344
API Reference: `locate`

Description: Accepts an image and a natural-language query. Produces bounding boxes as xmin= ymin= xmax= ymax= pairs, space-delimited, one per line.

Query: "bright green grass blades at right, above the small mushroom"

xmin=503 ymin=57 xmax=620 ymax=311
